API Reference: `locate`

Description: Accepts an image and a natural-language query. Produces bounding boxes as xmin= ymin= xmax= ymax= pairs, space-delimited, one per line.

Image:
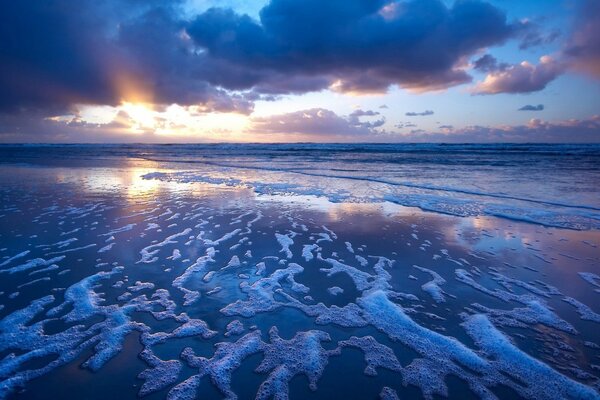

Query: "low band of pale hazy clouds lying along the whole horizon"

xmin=5 ymin=108 xmax=600 ymax=143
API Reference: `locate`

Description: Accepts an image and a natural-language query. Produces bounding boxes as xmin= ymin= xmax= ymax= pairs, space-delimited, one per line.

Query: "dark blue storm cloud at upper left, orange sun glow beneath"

xmin=0 ymin=0 xmax=253 ymax=115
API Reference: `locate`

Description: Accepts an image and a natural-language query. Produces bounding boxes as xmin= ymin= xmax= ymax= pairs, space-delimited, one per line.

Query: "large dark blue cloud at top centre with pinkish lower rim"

xmin=188 ymin=0 xmax=515 ymax=92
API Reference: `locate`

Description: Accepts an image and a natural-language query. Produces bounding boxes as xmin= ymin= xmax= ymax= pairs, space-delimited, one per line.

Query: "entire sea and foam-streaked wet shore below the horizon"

xmin=0 ymin=145 xmax=600 ymax=399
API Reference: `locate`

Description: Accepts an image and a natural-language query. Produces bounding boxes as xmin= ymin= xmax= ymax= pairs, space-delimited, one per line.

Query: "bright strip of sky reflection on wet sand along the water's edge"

xmin=2 ymin=162 xmax=598 ymax=274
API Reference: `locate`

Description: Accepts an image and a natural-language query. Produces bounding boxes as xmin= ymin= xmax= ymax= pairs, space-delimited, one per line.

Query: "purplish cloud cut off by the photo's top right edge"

xmin=564 ymin=0 xmax=600 ymax=78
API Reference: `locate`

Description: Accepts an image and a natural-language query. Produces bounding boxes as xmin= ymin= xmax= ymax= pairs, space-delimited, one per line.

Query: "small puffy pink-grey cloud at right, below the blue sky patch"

xmin=473 ymin=56 xmax=565 ymax=94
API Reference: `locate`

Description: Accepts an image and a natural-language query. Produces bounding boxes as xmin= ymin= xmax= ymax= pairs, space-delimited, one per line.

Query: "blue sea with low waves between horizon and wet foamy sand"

xmin=0 ymin=144 xmax=600 ymax=229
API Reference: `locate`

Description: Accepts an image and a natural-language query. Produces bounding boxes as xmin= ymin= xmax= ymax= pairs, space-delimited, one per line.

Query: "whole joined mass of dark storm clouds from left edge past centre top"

xmin=0 ymin=0 xmax=517 ymax=116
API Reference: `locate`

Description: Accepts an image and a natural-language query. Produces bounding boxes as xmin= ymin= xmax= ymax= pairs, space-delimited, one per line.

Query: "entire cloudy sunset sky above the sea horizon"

xmin=0 ymin=0 xmax=600 ymax=143
